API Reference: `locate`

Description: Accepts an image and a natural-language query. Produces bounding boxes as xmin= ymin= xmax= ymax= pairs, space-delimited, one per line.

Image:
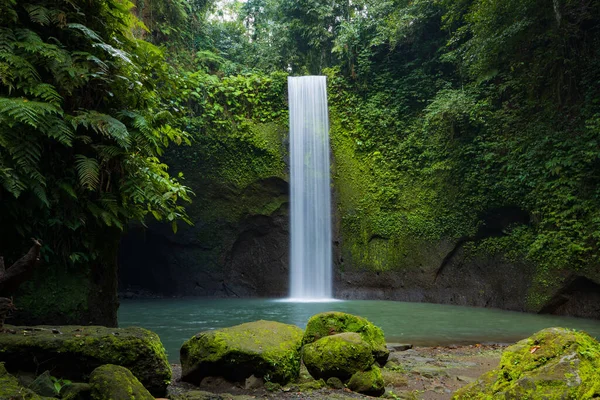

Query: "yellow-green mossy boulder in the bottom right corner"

xmin=453 ymin=328 xmax=600 ymax=399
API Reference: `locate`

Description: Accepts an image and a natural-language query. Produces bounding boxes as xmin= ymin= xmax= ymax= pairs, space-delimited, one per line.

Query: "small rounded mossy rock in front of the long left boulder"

xmin=90 ymin=364 xmax=154 ymax=400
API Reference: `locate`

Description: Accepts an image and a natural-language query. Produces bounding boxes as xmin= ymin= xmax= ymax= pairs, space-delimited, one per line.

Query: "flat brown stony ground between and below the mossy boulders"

xmin=168 ymin=343 xmax=508 ymax=400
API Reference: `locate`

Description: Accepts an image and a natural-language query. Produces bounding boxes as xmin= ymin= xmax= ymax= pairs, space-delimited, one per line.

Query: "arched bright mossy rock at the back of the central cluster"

xmin=302 ymin=311 xmax=390 ymax=365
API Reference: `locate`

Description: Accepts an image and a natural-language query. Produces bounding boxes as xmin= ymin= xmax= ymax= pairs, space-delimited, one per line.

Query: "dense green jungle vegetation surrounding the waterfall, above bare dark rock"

xmin=0 ymin=0 xmax=600 ymax=308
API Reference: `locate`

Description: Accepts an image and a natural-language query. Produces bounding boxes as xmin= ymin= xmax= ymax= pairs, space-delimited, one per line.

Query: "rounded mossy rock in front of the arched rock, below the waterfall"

xmin=302 ymin=332 xmax=375 ymax=380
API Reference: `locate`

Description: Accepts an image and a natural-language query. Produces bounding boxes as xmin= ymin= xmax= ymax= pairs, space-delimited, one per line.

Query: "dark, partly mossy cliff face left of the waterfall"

xmin=120 ymin=121 xmax=289 ymax=297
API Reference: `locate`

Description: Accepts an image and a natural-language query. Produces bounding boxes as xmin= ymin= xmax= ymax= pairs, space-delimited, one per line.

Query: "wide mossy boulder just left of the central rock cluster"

xmin=180 ymin=321 xmax=303 ymax=384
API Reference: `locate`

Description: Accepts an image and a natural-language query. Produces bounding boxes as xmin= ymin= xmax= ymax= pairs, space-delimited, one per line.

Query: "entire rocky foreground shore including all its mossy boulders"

xmin=0 ymin=311 xmax=600 ymax=400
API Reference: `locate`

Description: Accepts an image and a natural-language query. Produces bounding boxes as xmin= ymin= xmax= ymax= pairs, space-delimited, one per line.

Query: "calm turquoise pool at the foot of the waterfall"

xmin=119 ymin=298 xmax=600 ymax=362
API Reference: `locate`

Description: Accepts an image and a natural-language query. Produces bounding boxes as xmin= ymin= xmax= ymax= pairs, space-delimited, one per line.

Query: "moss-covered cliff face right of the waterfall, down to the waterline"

xmin=328 ymin=70 xmax=600 ymax=318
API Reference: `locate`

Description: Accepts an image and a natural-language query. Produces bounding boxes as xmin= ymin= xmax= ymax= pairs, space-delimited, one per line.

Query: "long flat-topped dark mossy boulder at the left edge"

xmin=0 ymin=326 xmax=171 ymax=396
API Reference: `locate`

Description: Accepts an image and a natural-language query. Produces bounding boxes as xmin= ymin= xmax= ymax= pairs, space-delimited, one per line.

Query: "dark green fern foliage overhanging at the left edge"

xmin=0 ymin=0 xmax=190 ymax=263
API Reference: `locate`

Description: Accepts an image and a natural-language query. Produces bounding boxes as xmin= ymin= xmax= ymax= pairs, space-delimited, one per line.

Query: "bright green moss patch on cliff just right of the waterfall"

xmin=331 ymin=104 xmax=474 ymax=271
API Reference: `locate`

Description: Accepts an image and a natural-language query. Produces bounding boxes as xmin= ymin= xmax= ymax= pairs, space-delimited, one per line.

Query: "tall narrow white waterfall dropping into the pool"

xmin=288 ymin=76 xmax=332 ymax=301
